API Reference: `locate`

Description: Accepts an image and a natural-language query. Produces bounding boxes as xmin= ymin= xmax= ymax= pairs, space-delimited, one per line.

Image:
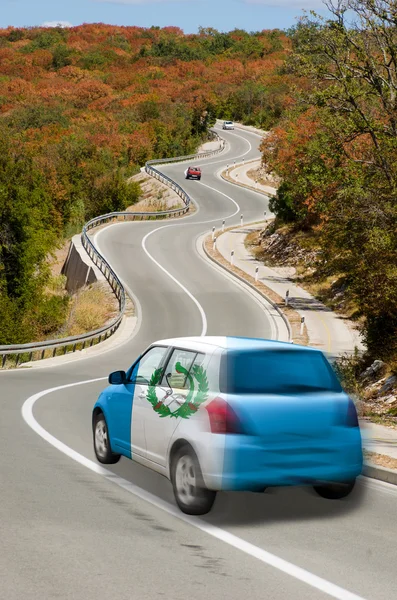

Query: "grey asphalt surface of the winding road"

xmin=0 ymin=130 xmax=397 ymax=600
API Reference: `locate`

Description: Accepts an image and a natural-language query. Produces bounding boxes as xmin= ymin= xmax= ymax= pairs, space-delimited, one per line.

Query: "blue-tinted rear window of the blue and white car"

xmin=219 ymin=350 xmax=342 ymax=394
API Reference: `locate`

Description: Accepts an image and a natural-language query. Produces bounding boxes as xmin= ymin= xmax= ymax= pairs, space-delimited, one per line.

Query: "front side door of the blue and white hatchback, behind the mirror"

xmin=129 ymin=346 xmax=169 ymax=460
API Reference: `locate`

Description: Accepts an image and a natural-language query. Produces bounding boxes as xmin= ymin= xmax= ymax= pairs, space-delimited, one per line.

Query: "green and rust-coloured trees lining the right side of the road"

xmin=256 ymin=0 xmax=397 ymax=370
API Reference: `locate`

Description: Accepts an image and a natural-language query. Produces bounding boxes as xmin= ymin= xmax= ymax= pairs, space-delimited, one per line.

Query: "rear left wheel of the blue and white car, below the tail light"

xmin=171 ymin=444 xmax=216 ymax=515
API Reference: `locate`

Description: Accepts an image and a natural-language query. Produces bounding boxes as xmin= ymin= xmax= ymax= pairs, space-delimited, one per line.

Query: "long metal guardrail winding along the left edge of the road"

xmin=0 ymin=131 xmax=225 ymax=369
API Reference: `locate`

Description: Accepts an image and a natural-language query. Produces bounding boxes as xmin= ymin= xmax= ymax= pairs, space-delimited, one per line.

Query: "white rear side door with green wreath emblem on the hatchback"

xmin=145 ymin=348 xmax=205 ymax=468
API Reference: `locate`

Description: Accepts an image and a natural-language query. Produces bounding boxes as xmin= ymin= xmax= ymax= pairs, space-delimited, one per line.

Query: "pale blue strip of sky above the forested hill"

xmin=0 ymin=0 xmax=327 ymax=33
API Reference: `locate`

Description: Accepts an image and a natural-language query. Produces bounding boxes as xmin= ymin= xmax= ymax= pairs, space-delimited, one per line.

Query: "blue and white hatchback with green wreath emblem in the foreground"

xmin=92 ymin=336 xmax=363 ymax=515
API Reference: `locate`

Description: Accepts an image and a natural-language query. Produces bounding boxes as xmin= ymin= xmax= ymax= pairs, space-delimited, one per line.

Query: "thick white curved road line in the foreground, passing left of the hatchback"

xmin=22 ymin=377 xmax=364 ymax=600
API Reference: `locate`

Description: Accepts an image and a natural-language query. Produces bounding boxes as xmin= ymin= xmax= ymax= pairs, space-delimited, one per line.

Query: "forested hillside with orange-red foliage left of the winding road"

xmin=0 ymin=24 xmax=289 ymax=344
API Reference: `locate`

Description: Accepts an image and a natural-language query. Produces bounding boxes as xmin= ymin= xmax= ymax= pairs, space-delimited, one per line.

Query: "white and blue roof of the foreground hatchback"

xmin=152 ymin=335 xmax=320 ymax=352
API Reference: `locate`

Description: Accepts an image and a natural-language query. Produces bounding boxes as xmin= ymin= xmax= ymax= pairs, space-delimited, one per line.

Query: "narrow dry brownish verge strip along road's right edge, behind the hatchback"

xmin=204 ymin=234 xmax=309 ymax=346
